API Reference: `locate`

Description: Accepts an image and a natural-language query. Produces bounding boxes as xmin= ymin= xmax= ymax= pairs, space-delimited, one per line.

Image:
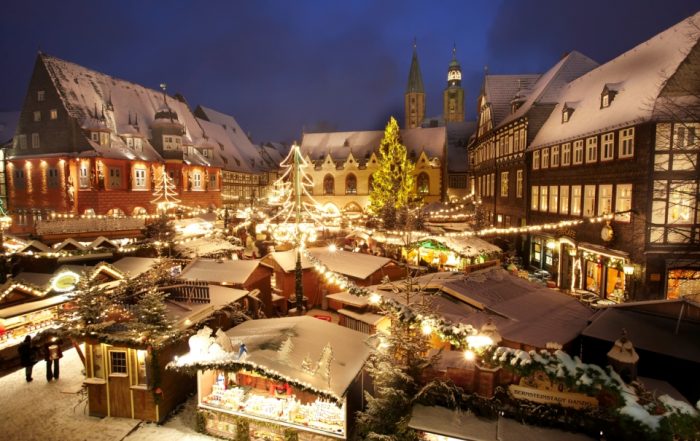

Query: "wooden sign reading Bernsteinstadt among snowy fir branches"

xmin=508 ymin=371 xmax=598 ymax=409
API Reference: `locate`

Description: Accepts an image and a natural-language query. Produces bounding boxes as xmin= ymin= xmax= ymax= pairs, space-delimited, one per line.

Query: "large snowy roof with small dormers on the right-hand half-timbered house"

xmin=530 ymin=12 xmax=700 ymax=149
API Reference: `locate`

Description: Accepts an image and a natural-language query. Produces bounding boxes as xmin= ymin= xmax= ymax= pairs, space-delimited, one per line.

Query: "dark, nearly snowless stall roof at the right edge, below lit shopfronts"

xmin=583 ymin=298 xmax=700 ymax=363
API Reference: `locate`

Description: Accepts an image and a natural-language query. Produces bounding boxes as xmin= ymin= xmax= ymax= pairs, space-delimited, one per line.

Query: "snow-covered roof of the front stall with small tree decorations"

xmin=171 ymin=316 xmax=370 ymax=399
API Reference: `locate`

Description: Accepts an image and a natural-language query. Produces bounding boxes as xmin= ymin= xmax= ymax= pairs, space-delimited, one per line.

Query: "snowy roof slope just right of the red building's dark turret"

xmin=196 ymin=106 xmax=268 ymax=171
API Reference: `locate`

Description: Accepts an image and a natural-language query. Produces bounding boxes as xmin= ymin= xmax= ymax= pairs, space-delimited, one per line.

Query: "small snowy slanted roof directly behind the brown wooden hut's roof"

xmin=179 ymin=259 xmax=260 ymax=285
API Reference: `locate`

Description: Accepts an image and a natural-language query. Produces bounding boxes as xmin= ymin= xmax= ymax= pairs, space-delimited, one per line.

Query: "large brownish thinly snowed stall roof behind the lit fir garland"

xmin=370 ymin=267 xmax=593 ymax=348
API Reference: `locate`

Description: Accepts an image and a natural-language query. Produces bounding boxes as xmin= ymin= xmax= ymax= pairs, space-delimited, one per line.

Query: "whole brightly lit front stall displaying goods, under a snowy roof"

xmin=169 ymin=316 xmax=370 ymax=441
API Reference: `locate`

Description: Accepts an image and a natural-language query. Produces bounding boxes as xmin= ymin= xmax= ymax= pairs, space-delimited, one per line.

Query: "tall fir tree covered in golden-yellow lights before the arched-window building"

xmin=369 ymin=117 xmax=415 ymax=223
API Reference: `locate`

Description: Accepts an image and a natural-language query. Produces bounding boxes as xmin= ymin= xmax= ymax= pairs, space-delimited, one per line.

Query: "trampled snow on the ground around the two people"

xmin=0 ymin=349 xmax=215 ymax=441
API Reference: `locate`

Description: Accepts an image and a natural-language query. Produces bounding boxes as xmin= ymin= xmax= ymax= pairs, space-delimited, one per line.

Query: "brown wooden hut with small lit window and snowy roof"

xmin=80 ymin=285 xmax=248 ymax=422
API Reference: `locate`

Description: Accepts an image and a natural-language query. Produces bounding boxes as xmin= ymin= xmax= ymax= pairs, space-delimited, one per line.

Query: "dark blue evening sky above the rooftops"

xmin=0 ymin=0 xmax=698 ymax=141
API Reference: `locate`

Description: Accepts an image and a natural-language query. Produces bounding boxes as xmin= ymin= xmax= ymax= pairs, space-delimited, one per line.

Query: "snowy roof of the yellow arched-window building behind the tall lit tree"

xmin=301 ymin=127 xmax=447 ymax=162
